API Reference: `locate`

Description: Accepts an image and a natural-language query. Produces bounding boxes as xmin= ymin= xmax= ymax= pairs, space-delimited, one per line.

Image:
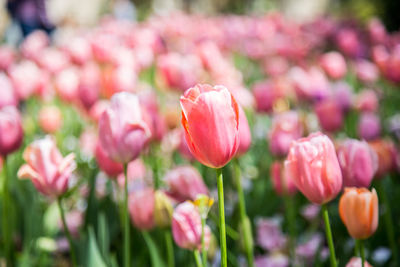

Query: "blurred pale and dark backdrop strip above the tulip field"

xmin=0 ymin=0 xmax=400 ymax=44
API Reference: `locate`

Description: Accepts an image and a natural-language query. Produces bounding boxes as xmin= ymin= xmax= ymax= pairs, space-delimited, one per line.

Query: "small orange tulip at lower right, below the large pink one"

xmin=339 ymin=187 xmax=379 ymax=239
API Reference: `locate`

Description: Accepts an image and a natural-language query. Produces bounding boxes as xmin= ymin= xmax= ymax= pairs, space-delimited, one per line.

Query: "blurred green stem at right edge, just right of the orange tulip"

xmin=377 ymin=177 xmax=398 ymax=266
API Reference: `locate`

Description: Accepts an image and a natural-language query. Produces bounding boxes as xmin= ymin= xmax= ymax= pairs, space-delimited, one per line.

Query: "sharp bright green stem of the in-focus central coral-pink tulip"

xmin=216 ymin=169 xmax=227 ymax=267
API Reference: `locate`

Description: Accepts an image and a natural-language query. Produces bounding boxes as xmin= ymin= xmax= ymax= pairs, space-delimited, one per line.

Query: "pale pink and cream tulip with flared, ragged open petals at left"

xmin=18 ymin=137 xmax=76 ymax=197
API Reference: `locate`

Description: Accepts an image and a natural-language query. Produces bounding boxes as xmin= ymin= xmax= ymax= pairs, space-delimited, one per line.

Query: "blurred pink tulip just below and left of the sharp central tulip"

xmin=164 ymin=165 xmax=208 ymax=201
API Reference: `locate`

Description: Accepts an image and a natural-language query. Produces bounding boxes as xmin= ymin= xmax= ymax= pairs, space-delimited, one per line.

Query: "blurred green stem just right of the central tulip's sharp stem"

xmin=233 ymin=159 xmax=254 ymax=267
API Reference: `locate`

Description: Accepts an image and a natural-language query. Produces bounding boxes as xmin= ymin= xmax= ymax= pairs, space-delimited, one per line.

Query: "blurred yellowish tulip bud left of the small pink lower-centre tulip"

xmin=154 ymin=191 xmax=173 ymax=228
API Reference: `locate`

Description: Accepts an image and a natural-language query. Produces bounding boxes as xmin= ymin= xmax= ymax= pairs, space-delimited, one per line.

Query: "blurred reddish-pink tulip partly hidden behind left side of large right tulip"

xmin=270 ymin=161 xmax=297 ymax=195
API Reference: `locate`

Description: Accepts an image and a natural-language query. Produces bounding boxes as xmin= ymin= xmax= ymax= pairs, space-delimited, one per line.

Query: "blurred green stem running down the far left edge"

xmin=2 ymin=157 xmax=12 ymax=266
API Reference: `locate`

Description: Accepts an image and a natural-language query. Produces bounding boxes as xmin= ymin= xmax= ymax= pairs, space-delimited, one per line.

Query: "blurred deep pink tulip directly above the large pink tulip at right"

xmin=315 ymin=98 xmax=343 ymax=132
